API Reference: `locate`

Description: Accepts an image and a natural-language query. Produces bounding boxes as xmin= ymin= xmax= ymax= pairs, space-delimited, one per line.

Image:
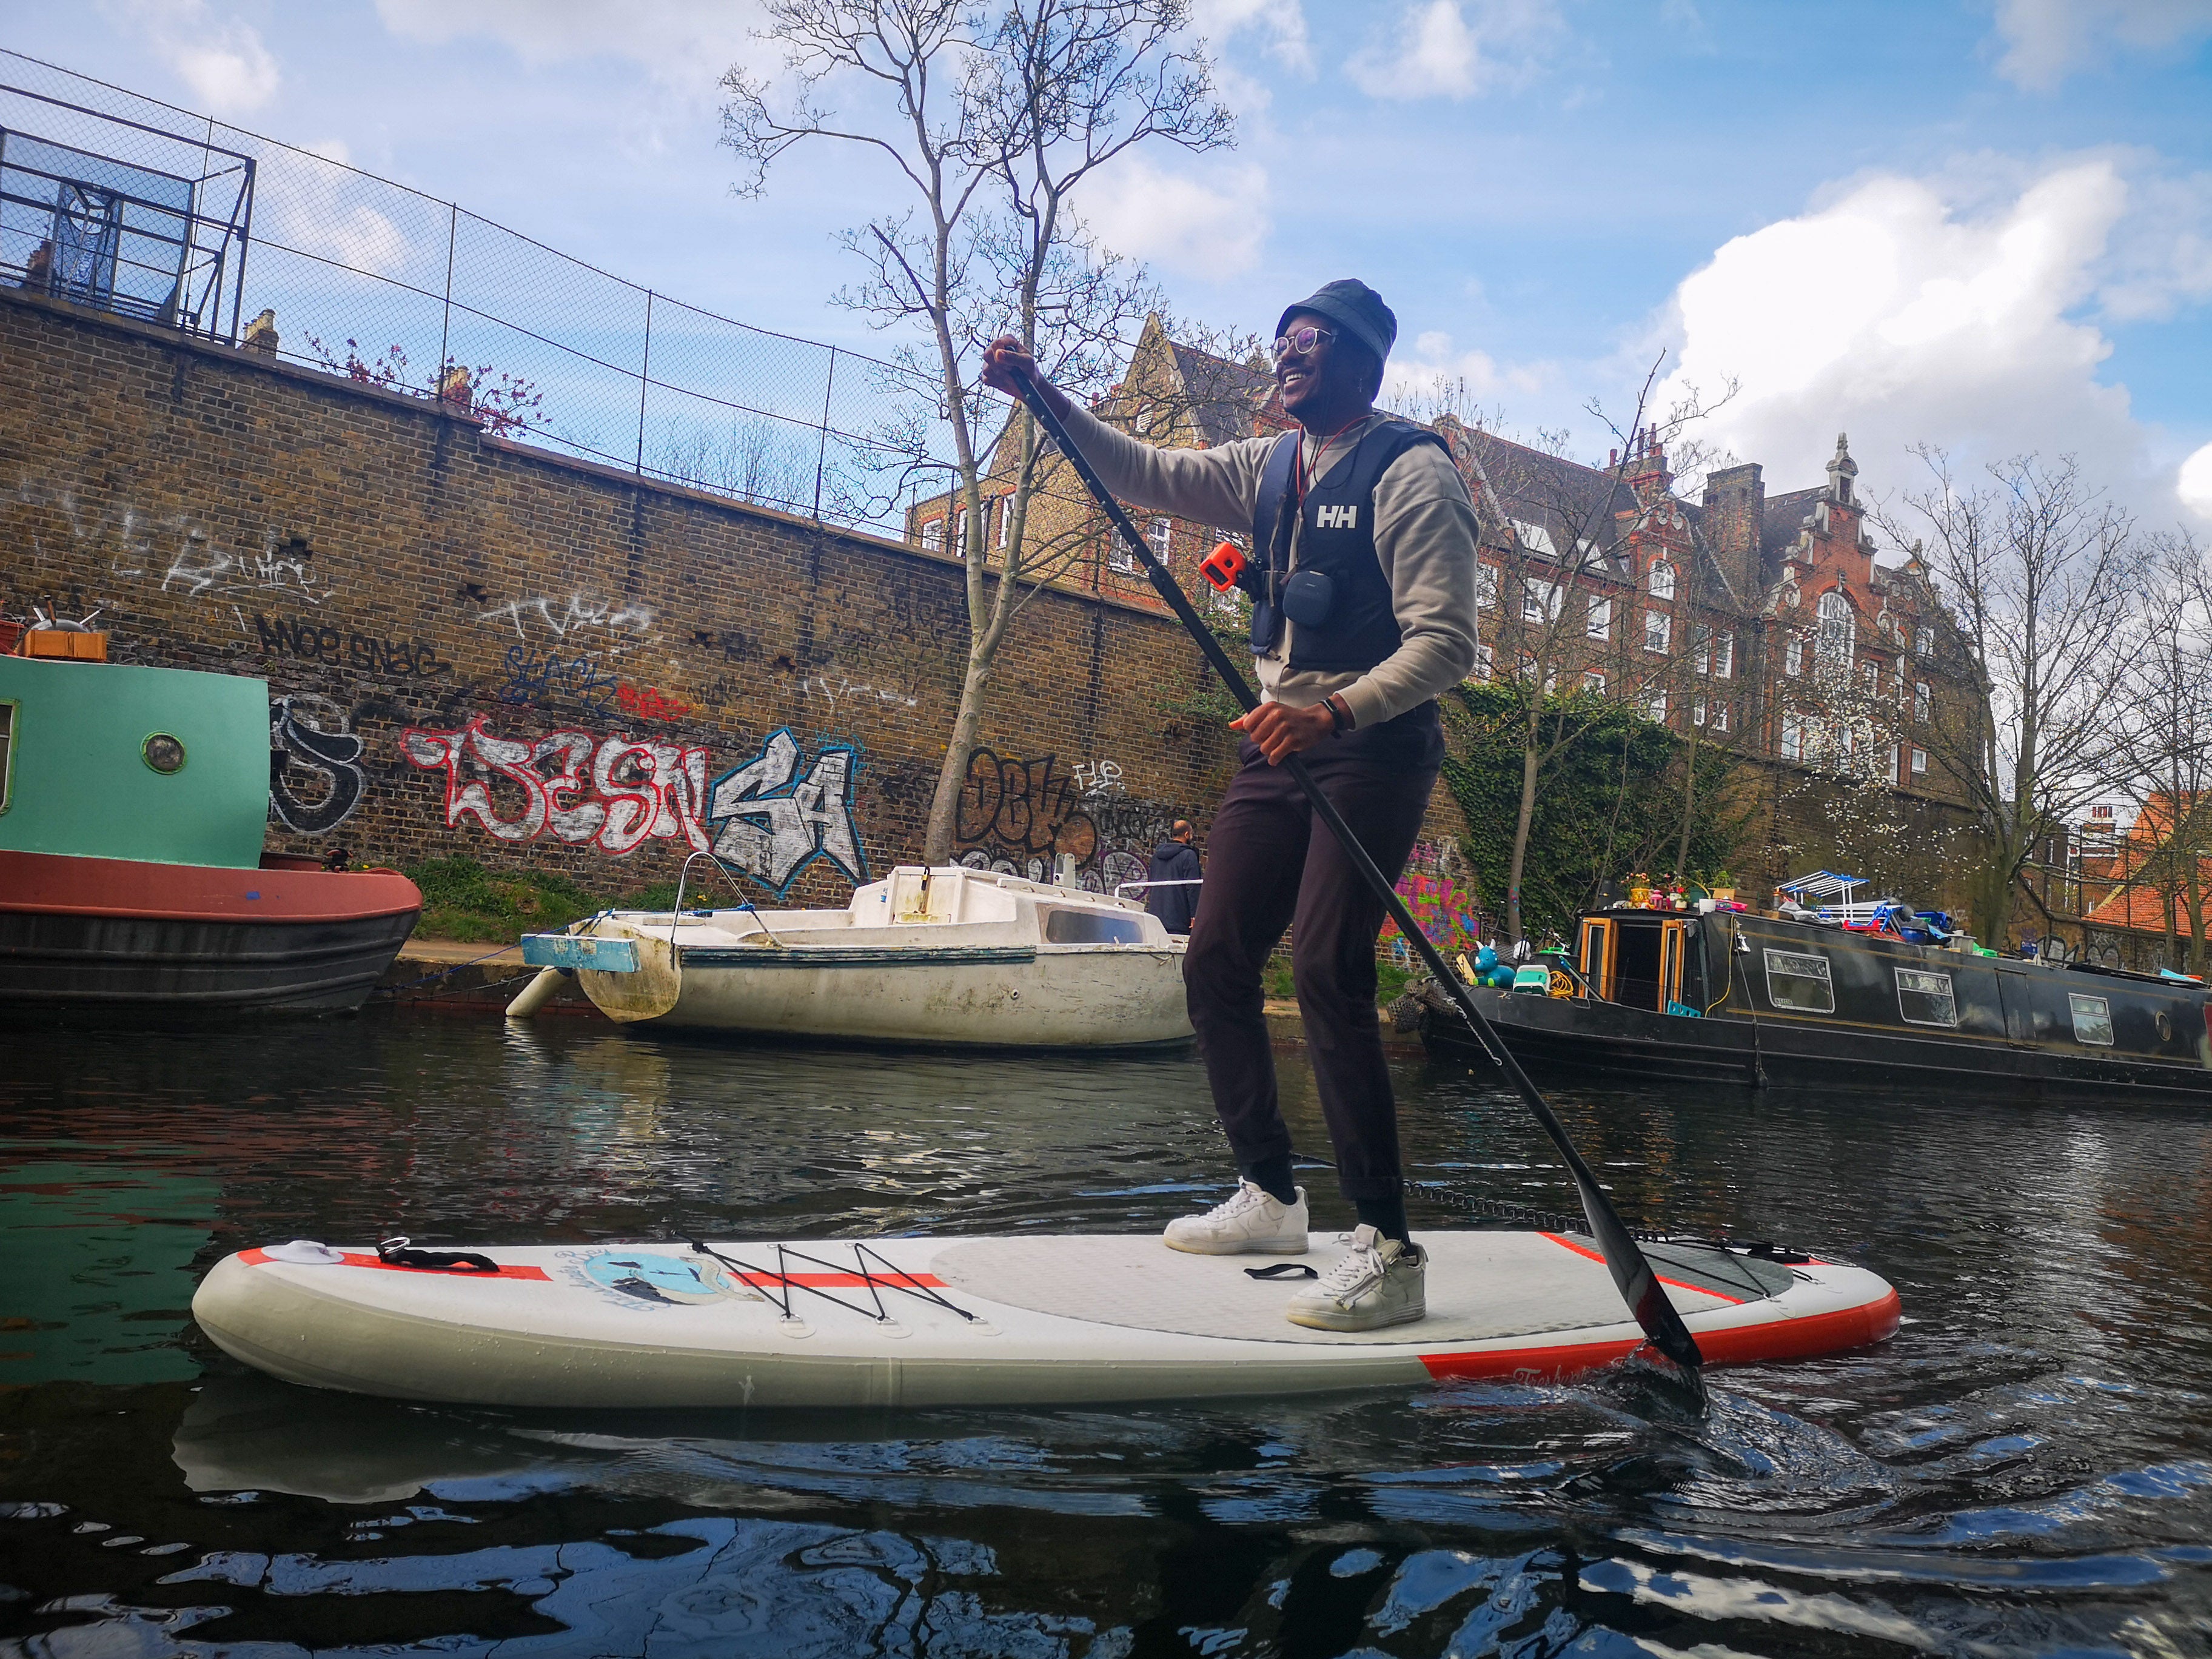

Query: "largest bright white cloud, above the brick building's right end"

xmin=1657 ymin=155 xmax=2212 ymax=513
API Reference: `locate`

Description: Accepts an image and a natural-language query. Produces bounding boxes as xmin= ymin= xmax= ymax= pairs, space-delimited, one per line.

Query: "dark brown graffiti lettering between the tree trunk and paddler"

xmin=953 ymin=748 xmax=1177 ymax=894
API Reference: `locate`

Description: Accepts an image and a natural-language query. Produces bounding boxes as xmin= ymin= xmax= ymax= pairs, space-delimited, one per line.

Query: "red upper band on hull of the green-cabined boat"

xmin=0 ymin=851 xmax=423 ymax=922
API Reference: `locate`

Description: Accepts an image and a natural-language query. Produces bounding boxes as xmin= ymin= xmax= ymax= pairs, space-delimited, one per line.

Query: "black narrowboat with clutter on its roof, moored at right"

xmin=1420 ymin=909 xmax=2212 ymax=1099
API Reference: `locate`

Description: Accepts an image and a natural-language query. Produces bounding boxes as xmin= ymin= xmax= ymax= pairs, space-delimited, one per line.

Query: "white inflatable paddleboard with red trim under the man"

xmin=192 ymin=1232 xmax=1898 ymax=1407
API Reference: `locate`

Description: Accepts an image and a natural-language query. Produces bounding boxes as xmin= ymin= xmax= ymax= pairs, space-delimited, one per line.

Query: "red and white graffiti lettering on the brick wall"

xmin=400 ymin=714 xmax=710 ymax=858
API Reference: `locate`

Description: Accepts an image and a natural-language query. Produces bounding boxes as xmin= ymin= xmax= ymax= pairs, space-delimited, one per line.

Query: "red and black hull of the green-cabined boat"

xmin=0 ymin=851 xmax=423 ymax=1022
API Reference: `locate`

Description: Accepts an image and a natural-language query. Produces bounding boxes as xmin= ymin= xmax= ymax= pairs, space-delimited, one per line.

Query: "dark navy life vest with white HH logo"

xmin=1252 ymin=420 xmax=1449 ymax=672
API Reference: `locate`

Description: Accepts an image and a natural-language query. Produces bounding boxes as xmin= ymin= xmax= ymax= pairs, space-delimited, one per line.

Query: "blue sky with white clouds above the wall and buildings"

xmin=13 ymin=0 xmax=2212 ymax=533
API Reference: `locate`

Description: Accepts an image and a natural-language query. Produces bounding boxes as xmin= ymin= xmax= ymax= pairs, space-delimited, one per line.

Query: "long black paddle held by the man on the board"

xmin=1017 ymin=376 xmax=1706 ymax=1400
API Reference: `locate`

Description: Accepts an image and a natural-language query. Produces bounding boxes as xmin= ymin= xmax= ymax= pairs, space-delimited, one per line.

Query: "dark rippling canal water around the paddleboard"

xmin=0 ymin=1015 xmax=2212 ymax=1659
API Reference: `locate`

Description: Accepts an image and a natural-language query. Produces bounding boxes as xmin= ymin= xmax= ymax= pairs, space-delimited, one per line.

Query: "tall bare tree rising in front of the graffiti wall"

xmin=723 ymin=0 xmax=1232 ymax=863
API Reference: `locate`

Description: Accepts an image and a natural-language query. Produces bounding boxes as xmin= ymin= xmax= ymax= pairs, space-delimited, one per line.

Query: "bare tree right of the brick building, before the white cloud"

xmin=1882 ymin=455 xmax=2143 ymax=945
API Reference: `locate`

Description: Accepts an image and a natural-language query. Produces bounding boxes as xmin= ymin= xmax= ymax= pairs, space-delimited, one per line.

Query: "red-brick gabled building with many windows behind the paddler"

xmin=909 ymin=317 xmax=1976 ymax=805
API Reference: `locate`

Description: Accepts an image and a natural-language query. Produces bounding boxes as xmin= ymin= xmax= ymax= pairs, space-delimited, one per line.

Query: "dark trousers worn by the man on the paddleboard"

xmin=1184 ymin=703 xmax=1444 ymax=1199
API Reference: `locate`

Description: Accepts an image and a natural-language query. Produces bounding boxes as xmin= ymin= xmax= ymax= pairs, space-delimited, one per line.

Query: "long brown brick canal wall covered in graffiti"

xmin=0 ymin=290 xmax=1458 ymax=924
